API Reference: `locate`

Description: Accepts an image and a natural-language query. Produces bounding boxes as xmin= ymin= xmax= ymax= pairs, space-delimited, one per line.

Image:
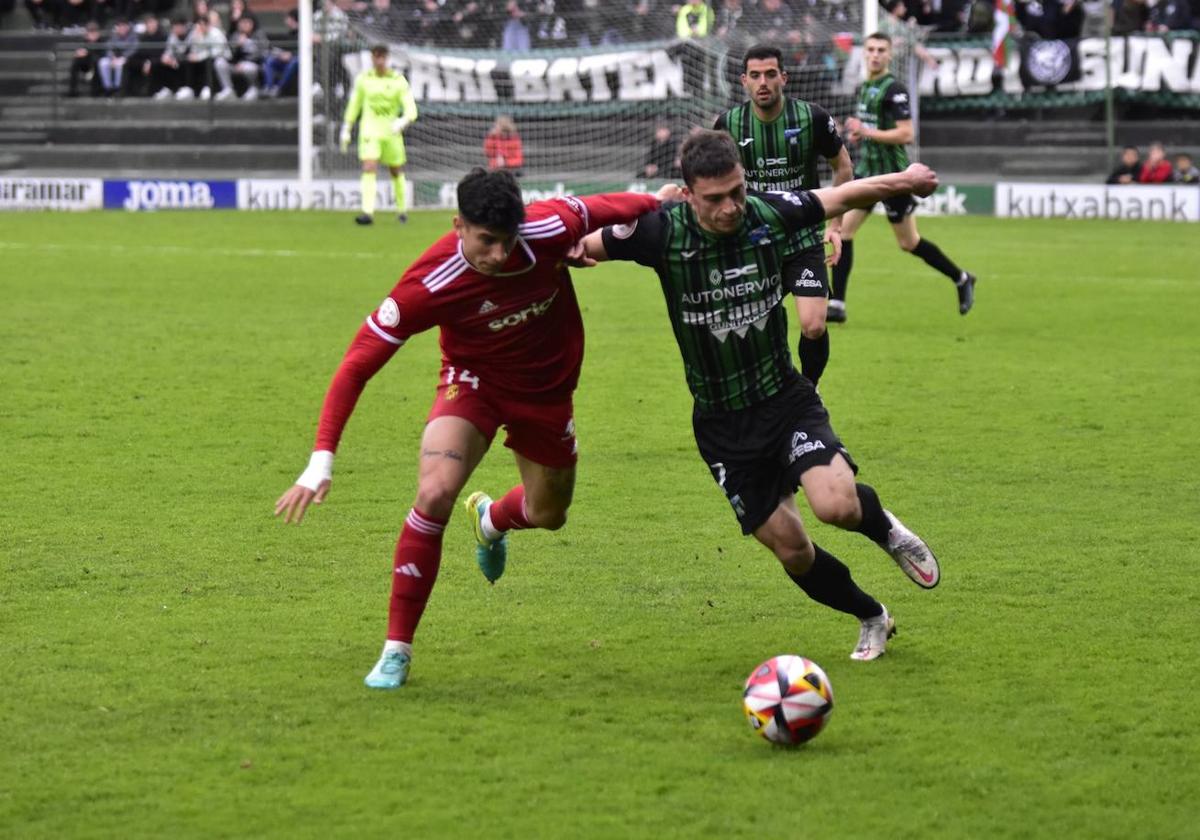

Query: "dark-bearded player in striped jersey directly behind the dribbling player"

xmin=713 ymin=44 xmax=854 ymax=385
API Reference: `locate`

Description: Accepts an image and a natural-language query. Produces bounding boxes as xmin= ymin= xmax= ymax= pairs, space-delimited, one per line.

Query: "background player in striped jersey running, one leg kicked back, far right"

xmin=828 ymin=32 xmax=976 ymax=320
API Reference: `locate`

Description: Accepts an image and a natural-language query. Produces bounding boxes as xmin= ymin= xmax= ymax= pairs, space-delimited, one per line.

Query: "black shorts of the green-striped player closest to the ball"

xmin=691 ymin=373 xmax=858 ymax=534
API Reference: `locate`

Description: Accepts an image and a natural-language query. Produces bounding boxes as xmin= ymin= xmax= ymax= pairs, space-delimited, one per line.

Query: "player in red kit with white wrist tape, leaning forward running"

xmin=275 ymin=169 xmax=674 ymax=689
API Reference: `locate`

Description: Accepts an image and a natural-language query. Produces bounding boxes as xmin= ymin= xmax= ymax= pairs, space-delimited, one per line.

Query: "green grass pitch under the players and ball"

xmin=0 ymin=212 xmax=1200 ymax=840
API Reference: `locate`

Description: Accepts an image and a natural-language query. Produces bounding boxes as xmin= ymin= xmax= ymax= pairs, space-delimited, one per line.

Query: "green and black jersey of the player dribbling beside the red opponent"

xmin=602 ymin=192 xmax=824 ymax=412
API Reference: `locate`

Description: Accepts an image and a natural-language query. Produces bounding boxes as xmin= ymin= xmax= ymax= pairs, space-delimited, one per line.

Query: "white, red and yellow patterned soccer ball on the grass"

xmin=742 ymin=654 xmax=833 ymax=746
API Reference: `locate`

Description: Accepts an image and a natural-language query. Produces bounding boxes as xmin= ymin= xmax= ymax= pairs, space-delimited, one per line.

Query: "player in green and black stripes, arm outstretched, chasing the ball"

xmin=583 ymin=131 xmax=941 ymax=660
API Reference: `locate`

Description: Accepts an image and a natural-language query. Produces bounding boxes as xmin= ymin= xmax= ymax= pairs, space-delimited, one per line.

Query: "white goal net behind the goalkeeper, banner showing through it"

xmin=313 ymin=0 xmax=914 ymax=206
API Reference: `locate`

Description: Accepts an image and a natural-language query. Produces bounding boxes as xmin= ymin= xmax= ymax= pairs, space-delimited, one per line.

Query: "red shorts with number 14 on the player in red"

xmin=428 ymin=367 xmax=578 ymax=469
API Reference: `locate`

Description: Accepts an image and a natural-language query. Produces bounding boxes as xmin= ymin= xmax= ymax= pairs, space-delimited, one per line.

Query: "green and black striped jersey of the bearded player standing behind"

xmin=713 ymin=96 xmax=842 ymax=250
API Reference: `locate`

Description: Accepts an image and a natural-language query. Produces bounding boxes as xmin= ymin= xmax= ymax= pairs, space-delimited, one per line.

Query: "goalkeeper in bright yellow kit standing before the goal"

xmin=340 ymin=44 xmax=416 ymax=224
